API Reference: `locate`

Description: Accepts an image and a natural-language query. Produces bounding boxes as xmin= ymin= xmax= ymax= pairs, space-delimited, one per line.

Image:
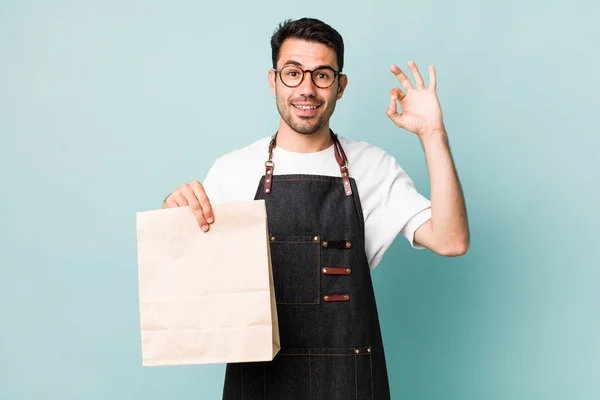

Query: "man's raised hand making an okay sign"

xmin=386 ymin=61 xmax=445 ymax=138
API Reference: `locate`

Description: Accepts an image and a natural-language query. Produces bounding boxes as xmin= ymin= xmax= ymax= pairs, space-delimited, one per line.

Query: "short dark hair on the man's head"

xmin=271 ymin=18 xmax=344 ymax=72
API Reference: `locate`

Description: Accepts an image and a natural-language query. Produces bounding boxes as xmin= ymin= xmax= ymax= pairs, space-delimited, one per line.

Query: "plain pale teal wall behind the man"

xmin=0 ymin=0 xmax=600 ymax=400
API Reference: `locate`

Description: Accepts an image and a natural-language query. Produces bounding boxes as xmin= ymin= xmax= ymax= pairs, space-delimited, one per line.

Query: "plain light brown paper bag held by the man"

xmin=137 ymin=200 xmax=280 ymax=366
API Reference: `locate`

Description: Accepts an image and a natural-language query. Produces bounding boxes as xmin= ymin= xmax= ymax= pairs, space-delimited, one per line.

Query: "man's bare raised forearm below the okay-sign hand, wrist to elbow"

xmin=420 ymin=131 xmax=469 ymax=254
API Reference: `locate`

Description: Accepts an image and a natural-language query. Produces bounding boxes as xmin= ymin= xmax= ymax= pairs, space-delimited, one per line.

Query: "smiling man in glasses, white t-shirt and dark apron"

xmin=164 ymin=18 xmax=469 ymax=400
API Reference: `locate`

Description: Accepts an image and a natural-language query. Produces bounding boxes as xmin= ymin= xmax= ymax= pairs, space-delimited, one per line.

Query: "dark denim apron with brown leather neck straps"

xmin=223 ymin=131 xmax=390 ymax=400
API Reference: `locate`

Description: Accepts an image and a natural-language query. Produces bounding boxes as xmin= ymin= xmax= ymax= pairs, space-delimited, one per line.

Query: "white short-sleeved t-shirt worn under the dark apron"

xmin=203 ymin=135 xmax=431 ymax=269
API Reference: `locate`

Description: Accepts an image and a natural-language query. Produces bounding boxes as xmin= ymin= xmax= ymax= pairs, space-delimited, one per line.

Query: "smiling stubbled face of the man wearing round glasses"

xmin=269 ymin=39 xmax=348 ymax=134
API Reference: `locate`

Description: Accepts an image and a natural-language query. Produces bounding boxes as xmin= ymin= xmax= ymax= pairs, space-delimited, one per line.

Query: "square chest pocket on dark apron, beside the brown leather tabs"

xmin=270 ymin=235 xmax=321 ymax=304
